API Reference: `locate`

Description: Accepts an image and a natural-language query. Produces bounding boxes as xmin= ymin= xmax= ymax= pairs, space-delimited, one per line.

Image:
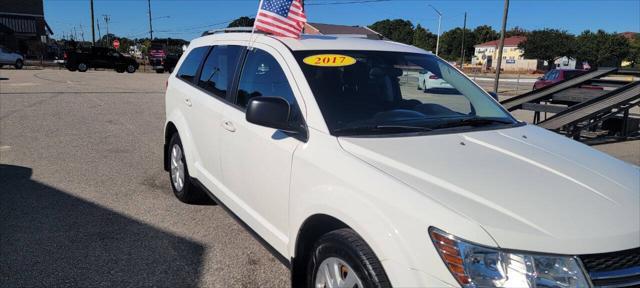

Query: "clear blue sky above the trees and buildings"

xmin=44 ymin=0 xmax=640 ymax=40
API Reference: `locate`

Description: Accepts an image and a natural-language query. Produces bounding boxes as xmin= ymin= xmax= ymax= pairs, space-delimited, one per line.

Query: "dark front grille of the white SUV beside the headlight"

xmin=580 ymin=248 xmax=640 ymax=287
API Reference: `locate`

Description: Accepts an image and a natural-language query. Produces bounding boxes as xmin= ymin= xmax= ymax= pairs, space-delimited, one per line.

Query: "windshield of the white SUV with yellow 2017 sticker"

xmin=295 ymin=51 xmax=517 ymax=135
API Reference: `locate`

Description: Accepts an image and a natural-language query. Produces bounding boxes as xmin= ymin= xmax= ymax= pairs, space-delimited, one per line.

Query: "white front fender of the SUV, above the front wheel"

xmin=287 ymin=129 xmax=496 ymax=287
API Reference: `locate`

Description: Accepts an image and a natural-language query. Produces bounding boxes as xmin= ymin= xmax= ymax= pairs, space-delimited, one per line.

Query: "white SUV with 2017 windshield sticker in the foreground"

xmin=165 ymin=29 xmax=640 ymax=288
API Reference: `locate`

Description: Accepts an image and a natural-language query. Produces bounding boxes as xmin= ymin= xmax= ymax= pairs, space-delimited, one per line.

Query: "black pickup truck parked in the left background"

xmin=64 ymin=47 xmax=140 ymax=73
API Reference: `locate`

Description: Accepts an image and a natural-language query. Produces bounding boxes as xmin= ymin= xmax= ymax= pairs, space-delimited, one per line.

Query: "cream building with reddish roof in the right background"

xmin=471 ymin=36 xmax=539 ymax=71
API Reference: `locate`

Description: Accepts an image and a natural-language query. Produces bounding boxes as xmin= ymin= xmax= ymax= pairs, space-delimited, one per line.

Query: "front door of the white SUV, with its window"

xmin=220 ymin=45 xmax=303 ymax=255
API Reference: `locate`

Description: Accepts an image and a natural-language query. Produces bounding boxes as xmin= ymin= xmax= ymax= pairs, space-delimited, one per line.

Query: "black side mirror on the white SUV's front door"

xmin=246 ymin=96 xmax=300 ymax=133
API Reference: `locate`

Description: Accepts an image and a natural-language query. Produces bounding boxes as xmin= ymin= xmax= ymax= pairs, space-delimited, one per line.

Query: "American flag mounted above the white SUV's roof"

xmin=255 ymin=0 xmax=307 ymax=38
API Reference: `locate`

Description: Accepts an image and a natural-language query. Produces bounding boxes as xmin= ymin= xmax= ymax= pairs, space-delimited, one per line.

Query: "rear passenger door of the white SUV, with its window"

xmin=188 ymin=45 xmax=244 ymax=190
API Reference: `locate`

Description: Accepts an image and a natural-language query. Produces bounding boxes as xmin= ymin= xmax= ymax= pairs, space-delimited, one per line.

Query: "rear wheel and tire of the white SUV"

xmin=167 ymin=133 xmax=205 ymax=204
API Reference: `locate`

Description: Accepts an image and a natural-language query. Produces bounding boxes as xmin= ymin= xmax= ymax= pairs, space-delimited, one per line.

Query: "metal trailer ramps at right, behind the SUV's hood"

xmin=501 ymin=68 xmax=640 ymax=144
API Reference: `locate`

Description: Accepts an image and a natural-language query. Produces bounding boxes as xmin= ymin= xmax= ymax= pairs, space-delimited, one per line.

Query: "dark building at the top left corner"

xmin=0 ymin=0 xmax=53 ymax=59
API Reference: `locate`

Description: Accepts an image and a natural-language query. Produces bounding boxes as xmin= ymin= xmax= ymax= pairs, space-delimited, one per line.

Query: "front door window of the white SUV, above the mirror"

xmin=236 ymin=48 xmax=296 ymax=108
